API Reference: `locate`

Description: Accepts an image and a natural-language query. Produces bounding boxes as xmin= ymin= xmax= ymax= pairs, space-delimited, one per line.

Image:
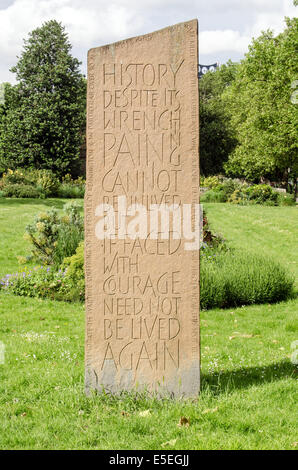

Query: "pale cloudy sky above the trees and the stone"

xmin=0 ymin=0 xmax=298 ymax=83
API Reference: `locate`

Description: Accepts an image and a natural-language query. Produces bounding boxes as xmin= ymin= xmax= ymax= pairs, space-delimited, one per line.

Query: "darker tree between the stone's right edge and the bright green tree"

xmin=200 ymin=62 xmax=237 ymax=176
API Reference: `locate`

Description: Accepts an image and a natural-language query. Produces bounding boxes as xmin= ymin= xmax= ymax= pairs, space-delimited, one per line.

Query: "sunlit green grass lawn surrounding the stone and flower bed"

xmin=0 ymin=199 xmax=298 ymax=449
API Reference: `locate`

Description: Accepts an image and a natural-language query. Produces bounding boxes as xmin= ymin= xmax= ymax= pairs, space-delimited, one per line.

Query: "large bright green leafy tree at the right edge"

xmin=223 ymin=18 xmax=298 ymax=191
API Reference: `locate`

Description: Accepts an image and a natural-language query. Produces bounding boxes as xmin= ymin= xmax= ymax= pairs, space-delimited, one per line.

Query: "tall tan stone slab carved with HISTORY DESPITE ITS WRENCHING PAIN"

xmin=85 ymin=20 xmax=200 ymax=397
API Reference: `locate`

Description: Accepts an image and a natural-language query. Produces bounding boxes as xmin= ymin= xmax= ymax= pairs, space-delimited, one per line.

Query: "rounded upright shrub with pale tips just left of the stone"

xmin=25 ymin=203 xmax=84 ymax=266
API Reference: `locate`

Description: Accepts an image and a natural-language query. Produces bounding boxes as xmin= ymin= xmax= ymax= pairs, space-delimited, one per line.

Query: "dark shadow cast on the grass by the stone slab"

xmin=201 ymin=361 xmax=298 ymax=395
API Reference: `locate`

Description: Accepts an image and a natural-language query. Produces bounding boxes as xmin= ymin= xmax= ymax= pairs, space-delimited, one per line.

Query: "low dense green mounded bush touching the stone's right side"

xmin=200 ymin=251 xmax=294 ymax=309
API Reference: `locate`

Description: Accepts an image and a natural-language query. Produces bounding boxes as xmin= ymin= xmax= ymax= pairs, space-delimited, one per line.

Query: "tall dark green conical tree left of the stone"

xmin=0 ymin=20 xmax=86 ymax=175
